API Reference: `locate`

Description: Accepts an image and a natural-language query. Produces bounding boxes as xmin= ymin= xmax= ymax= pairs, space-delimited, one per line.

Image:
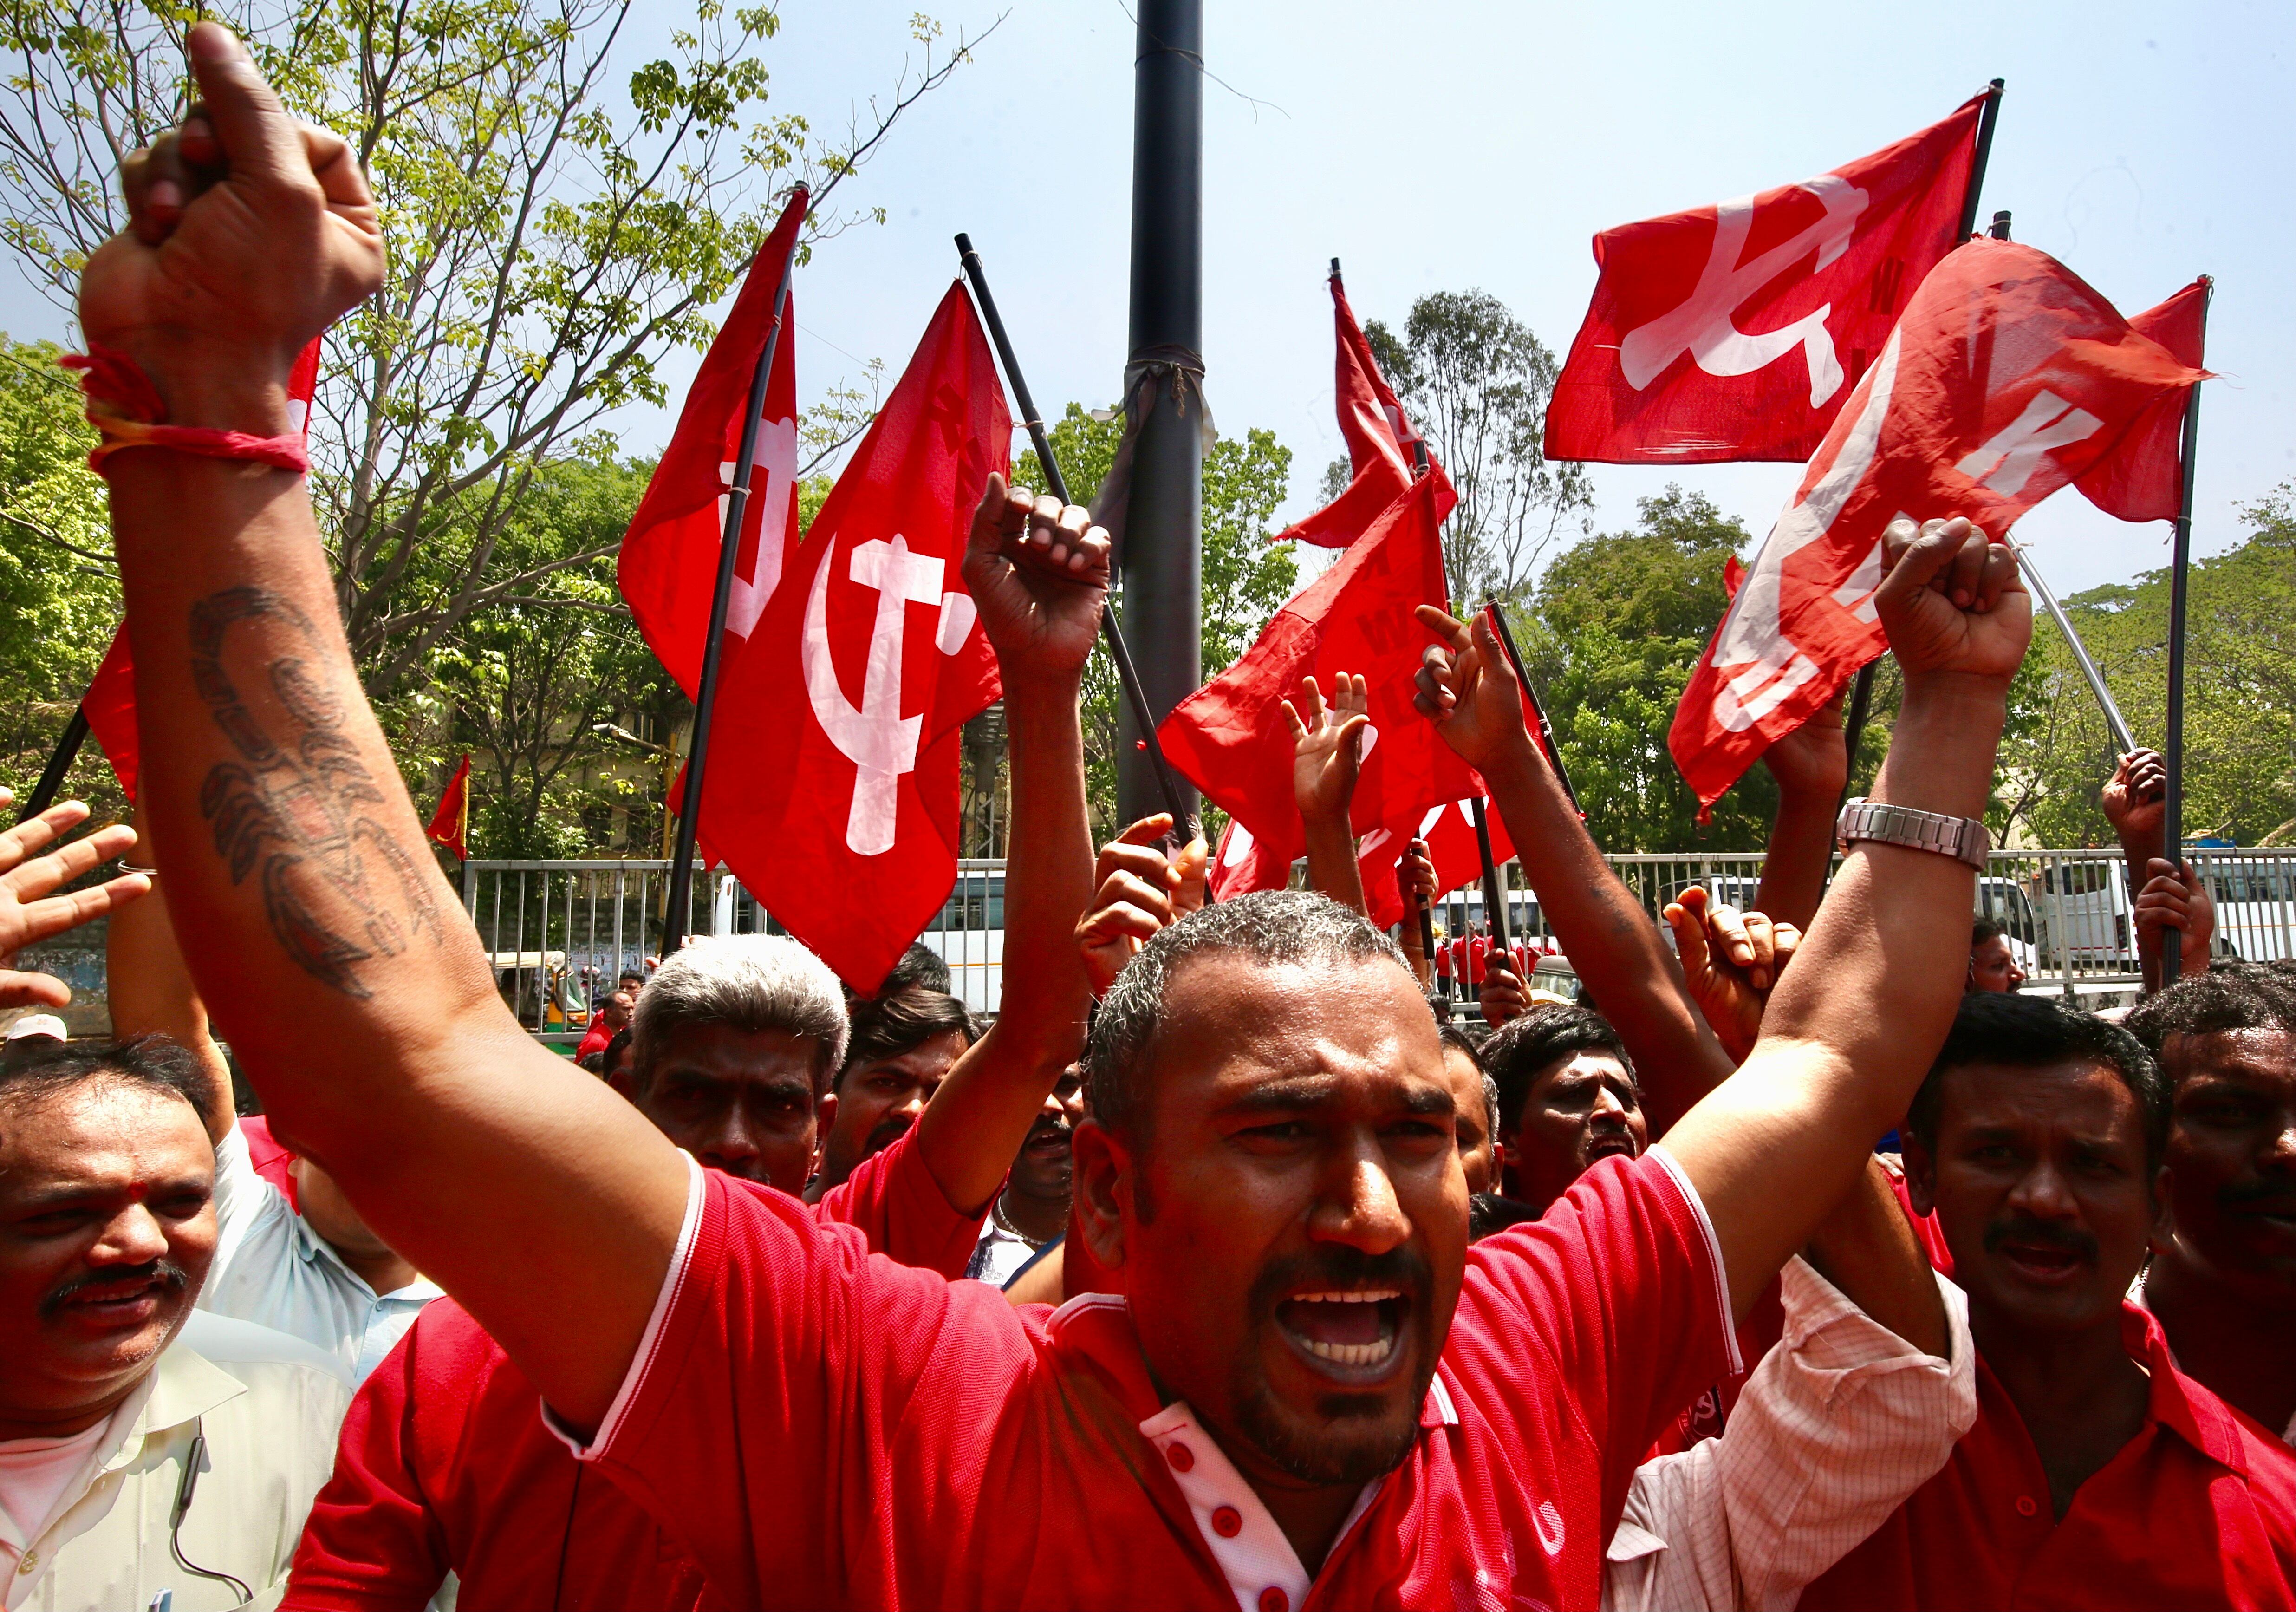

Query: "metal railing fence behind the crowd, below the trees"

xmin=462 ymin=849 xmax=2296 ymax=1033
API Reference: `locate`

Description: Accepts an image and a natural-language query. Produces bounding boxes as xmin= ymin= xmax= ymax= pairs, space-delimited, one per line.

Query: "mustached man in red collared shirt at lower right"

xmin=1786 ymin=992 xmax=2296 ymax=1612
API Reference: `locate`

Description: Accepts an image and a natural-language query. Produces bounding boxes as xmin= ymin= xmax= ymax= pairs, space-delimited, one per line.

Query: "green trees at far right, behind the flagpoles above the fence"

xmin=2002 ymin=482 xmax=2296 ymax=845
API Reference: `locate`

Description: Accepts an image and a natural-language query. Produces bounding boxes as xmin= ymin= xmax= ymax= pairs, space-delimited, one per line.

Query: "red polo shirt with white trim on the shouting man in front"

xmin=565 ymin=1150 xmax=1736 ymax=1612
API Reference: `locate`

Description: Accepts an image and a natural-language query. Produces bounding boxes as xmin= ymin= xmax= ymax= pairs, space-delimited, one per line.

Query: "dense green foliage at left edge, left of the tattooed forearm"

xmin=0 ymin=335 xmax=124 ymax=817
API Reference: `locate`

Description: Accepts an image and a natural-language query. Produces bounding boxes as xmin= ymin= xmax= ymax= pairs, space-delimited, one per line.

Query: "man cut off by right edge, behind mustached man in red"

xmin=2128 ymin=962 xmax=2296 ymax=1444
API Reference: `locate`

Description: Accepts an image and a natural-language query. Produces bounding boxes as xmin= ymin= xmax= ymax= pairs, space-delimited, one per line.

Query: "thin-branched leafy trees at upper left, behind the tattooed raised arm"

xmin=0 ymin=0 xmax=969 ymax=854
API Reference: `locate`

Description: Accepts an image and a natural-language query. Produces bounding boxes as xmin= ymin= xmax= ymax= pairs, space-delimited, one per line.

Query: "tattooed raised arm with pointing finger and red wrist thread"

xmin=80 ymin=23 xmax=689 ymax=1426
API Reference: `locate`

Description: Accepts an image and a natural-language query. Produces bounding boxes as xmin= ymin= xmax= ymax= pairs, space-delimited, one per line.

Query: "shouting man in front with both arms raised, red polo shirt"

xmin=94 ymin=50 xmax=2029 ymax=1612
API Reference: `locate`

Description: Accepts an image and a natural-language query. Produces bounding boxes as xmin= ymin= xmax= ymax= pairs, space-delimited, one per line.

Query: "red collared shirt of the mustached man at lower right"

xmin=1802 ymin=1306 xmax=2296 ymax=1612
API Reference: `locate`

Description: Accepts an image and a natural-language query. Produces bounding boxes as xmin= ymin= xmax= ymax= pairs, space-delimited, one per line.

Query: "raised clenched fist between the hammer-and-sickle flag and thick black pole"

xmin=964 ymin=471 xmax=1109 ymax=684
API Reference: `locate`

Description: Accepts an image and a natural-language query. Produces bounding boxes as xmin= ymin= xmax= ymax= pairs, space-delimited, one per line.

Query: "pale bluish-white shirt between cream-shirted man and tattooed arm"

xmin=200 ymin=1125 xmax=441 ymax=1385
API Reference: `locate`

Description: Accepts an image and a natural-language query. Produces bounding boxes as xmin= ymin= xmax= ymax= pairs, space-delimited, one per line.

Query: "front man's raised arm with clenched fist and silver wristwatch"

xmin=1665 ymin=519 xmax=2032 ymax=1313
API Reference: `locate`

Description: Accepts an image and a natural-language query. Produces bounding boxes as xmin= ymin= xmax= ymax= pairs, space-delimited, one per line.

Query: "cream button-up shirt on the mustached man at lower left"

xmin=0 ymin=1311 xmax=351 ymax=1612
